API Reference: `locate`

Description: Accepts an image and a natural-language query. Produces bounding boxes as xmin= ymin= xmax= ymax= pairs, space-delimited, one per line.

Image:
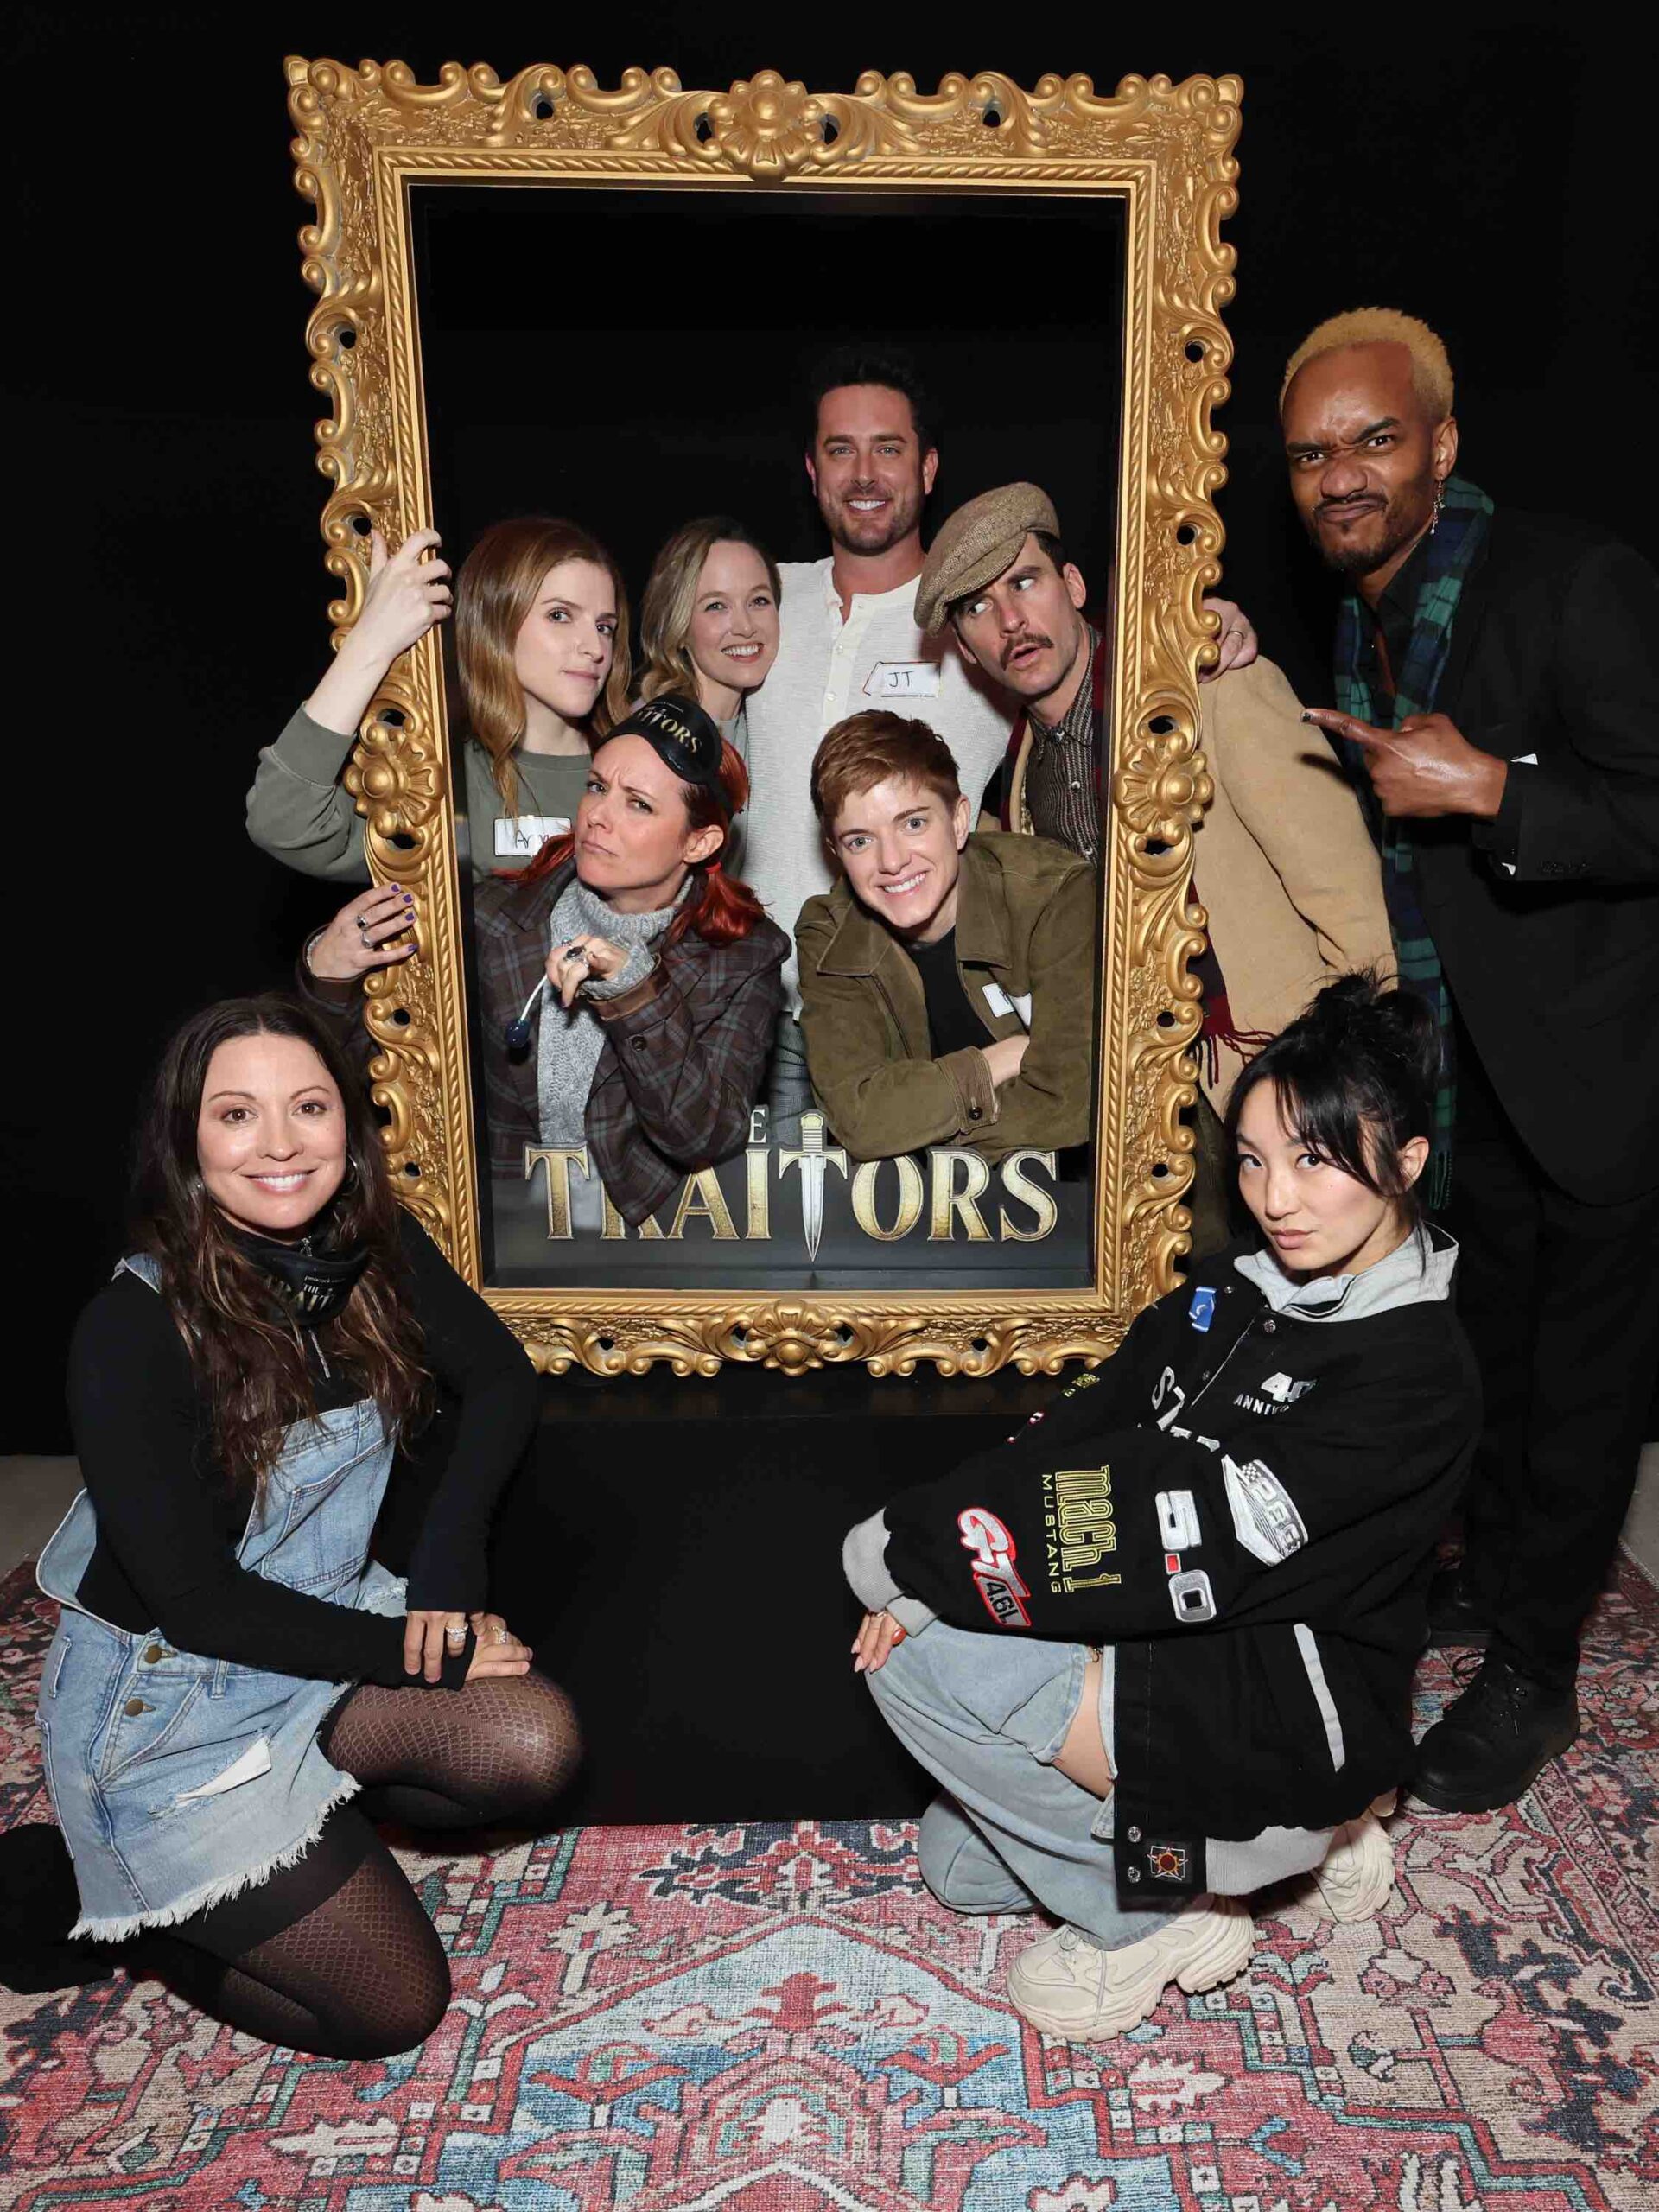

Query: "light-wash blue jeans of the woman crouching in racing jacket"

xmin=868 ymin=1621 xmax=1330 ymax=1951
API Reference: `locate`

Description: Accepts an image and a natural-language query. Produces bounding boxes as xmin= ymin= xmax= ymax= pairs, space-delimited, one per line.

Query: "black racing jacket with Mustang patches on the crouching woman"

xmin=885 ymin=1230 xmax=1480 ymax=1900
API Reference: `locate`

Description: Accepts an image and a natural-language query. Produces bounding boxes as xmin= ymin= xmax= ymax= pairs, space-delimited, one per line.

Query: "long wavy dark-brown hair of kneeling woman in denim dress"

xmin=133 ymin=993 xmax=431 ymax=1496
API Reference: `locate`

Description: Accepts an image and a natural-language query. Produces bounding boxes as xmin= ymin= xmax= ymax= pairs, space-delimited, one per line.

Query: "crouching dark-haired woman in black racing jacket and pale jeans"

xmin=845 ymin=976 xmax=1480 ymax=2039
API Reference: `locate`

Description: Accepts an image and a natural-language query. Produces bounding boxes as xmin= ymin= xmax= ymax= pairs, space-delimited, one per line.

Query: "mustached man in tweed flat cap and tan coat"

xmin=916 ymin=485 xmax=1394 ymax=1203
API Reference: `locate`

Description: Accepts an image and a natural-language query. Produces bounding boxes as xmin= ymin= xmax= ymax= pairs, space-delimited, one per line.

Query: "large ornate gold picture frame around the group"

xmin=285 ymin=58 xmax=1241 ymax=1374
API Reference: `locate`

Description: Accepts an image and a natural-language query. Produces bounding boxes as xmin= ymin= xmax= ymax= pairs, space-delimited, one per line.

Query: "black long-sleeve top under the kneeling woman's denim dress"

xmin=68 ymin=1212 xmax=537 ymax=1686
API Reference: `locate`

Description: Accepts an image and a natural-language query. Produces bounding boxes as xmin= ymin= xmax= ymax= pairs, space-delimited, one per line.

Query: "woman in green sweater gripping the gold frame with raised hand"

xmin=248 ymin=515 xmax=628 ymax=882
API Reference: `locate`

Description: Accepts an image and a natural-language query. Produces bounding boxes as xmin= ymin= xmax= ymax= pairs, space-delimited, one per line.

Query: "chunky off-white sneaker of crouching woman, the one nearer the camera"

xmin=1008 ymin=1897 xmax=1255 ymax=2044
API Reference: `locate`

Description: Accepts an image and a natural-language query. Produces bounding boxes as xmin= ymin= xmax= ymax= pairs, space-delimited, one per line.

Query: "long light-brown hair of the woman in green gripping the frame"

xmin=455 ymin=515 xmax=632 ymax=814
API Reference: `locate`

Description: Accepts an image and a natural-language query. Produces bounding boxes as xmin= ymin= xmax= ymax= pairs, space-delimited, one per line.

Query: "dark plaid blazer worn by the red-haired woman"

xmin=474 ymin=868 xmax=790 ymax=1224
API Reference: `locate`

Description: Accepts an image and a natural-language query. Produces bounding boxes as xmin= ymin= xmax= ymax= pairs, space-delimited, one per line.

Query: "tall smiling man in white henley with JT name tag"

xmin=743 ymin=345 xmax=1256 ymax=1128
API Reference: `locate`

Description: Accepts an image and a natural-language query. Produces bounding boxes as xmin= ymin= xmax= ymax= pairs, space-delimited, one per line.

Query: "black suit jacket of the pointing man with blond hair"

xmin=1414 ymin=509 xmax=1659 ymax=1204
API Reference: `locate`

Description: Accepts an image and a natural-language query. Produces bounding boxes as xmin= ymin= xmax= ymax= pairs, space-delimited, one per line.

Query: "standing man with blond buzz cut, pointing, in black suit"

xmin=1281 ymin=308 xmax=1659 ymax=1812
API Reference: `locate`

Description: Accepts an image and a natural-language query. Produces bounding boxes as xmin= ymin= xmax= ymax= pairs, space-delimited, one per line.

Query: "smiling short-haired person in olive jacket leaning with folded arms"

xmin=794 ymin=710 xmax=1099 ymax=1159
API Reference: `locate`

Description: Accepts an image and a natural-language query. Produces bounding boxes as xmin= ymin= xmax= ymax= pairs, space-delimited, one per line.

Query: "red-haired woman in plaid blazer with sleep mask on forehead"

xmin=305 ymin=692 xmax=790 ymax=1228
